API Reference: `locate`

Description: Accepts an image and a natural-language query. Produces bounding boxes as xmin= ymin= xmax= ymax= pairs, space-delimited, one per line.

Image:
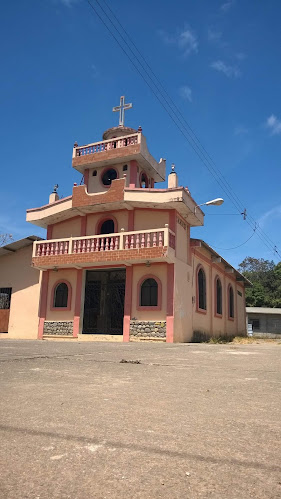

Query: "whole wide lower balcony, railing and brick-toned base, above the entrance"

xmin=32 ymin=226 xmax=175 ymax=270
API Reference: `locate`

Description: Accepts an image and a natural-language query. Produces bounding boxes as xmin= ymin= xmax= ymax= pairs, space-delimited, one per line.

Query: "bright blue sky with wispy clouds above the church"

xmin=0 ymin=0 xmax=281 ymax=266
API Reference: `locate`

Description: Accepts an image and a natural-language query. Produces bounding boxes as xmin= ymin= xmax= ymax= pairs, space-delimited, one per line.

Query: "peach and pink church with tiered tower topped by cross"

xmin=0 ymin=97 xmax=250 ymax=343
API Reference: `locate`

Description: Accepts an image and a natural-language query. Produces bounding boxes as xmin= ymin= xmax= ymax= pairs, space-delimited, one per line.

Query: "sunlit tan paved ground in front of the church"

xmin=0 ymin=340 xmax=281 ymax=499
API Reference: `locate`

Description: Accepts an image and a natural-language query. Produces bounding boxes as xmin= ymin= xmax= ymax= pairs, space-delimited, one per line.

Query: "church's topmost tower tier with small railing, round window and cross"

xmin=72 ymin=96 xmax=166 ymax=194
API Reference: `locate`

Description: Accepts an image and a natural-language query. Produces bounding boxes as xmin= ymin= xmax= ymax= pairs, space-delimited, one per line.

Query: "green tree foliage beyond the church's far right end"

xmin=239 ymin=256 xmax=281 ymax=308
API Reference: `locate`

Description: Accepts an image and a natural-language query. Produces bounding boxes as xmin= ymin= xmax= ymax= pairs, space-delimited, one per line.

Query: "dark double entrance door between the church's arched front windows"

xmin=83 ymin=269 xmax=126 ymax=334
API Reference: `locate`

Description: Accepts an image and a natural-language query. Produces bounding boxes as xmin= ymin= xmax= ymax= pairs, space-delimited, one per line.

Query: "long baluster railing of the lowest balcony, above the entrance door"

xmin=33 ymin=226 xmax=175 ymax=257
